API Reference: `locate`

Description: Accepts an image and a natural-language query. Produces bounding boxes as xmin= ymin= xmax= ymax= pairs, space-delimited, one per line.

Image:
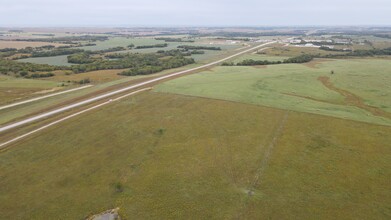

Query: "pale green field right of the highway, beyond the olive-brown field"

xmin=155 ymin=59 xmax=391 ymax=125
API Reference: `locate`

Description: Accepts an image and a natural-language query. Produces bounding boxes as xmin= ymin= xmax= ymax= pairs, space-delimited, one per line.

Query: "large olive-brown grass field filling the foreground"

xmin=0 ymin=92 xmax=391 ymax=219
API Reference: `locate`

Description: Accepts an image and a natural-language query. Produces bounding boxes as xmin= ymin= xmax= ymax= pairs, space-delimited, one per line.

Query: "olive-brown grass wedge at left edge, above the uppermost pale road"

xmin=0 ymin=76 xmax=59 ymax=105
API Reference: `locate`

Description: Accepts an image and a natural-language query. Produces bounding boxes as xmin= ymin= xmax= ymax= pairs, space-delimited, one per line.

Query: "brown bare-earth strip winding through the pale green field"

xmin=318 ymin=76 xmax=391 ymax=119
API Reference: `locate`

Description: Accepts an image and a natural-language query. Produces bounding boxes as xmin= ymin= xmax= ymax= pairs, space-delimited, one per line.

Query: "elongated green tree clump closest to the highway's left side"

xmin=119 ymin=56 xmax=194 ymax=76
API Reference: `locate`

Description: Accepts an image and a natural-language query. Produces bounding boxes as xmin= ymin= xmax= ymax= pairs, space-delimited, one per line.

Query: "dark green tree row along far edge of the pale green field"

xmin=233 ymin=54 xmax=314 ymax=66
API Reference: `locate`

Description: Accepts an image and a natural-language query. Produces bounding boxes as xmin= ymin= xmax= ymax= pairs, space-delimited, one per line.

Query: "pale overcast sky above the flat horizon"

xmin=0 ymin=0 xmax=391 ymax=27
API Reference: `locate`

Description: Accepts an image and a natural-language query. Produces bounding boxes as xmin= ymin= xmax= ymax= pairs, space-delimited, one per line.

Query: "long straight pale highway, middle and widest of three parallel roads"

xmin=0 ymin=41 xmax=276 ymax=132
